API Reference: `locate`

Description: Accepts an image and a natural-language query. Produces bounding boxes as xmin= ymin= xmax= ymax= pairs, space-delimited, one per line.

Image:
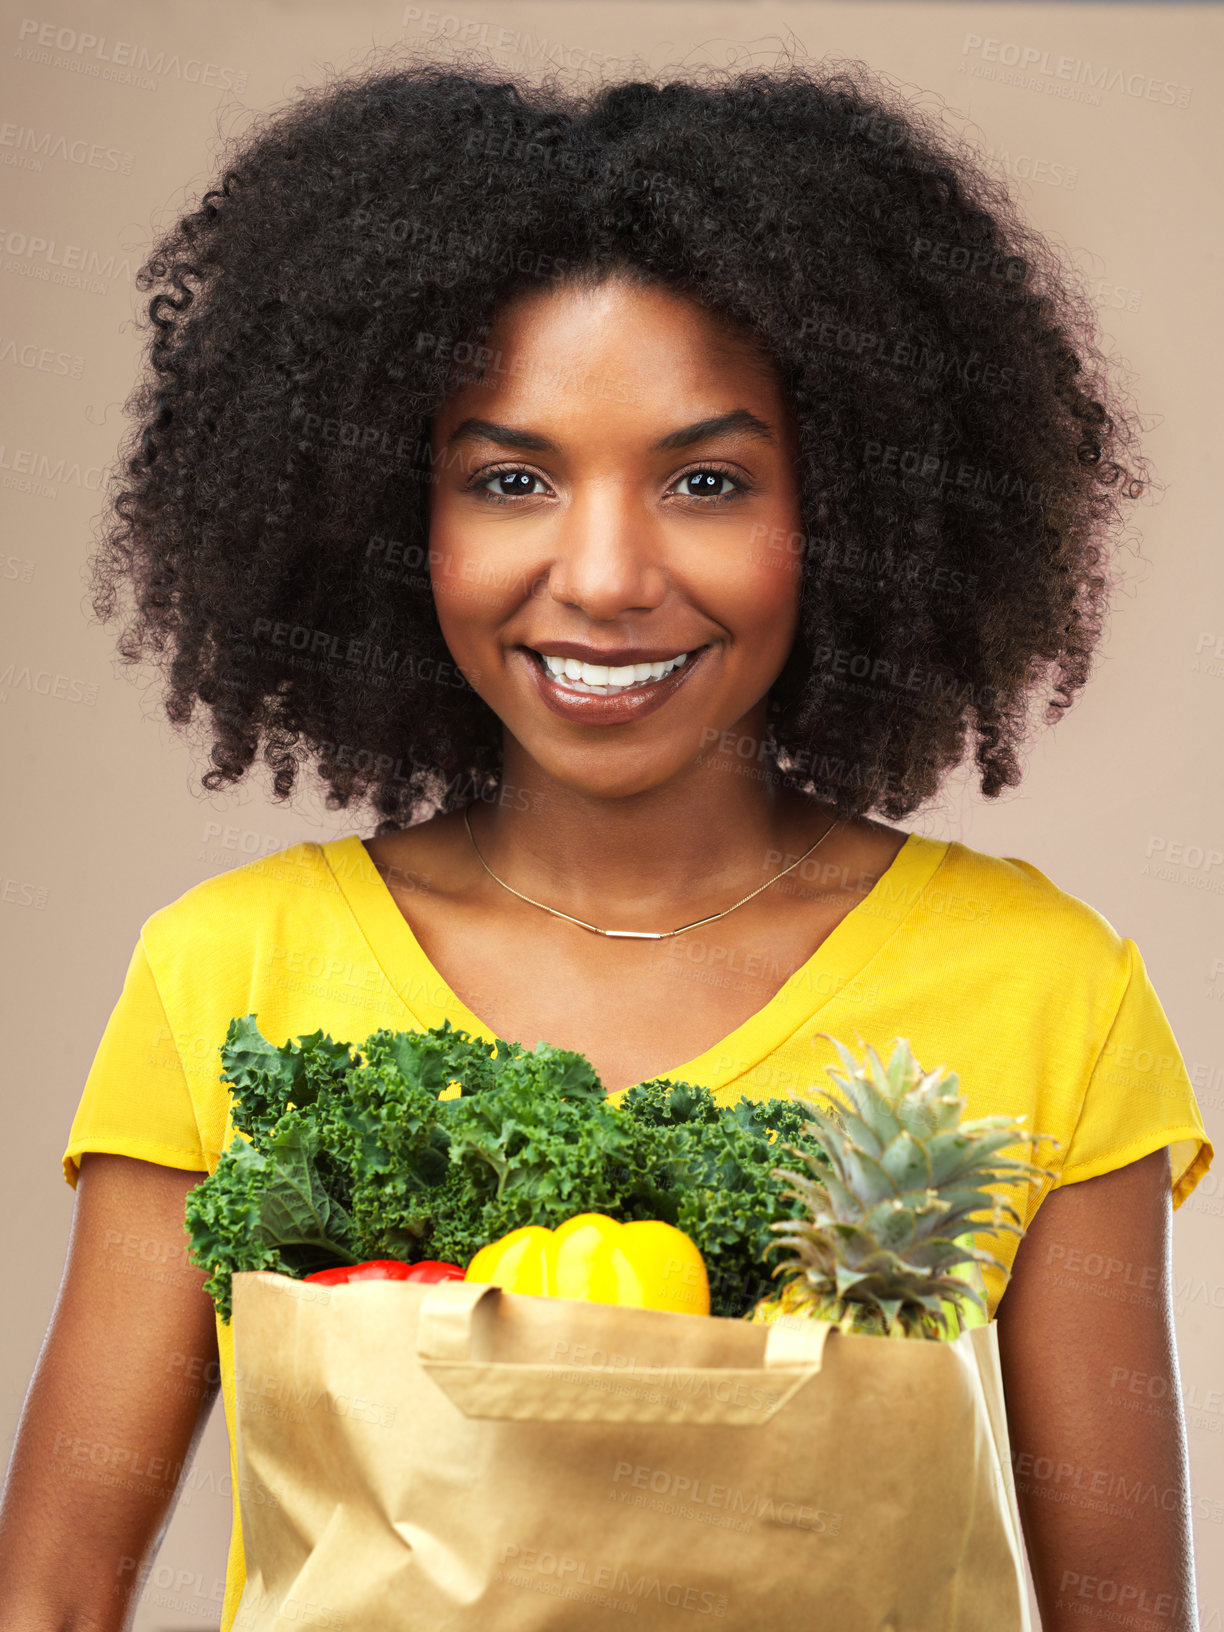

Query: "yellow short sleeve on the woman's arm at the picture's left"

xmin=64 ymin=938 xmax=209 ymax=1190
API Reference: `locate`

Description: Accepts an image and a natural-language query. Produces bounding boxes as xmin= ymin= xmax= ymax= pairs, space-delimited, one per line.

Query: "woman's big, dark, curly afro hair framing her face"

xmin=91 ymin=44 xmax=1147 ymax=834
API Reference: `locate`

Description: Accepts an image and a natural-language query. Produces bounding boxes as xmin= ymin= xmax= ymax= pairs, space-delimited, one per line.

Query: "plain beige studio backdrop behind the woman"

xmin=0 ymin=0 xmax=1224 ymax=1632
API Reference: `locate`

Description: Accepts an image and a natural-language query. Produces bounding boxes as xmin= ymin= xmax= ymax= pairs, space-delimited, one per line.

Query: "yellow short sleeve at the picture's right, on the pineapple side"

xmin=1059 ymin=940 xmax=1214 ymax=1208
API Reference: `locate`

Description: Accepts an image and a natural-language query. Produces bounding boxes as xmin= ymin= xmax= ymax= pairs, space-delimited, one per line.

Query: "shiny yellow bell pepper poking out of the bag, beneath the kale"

xmin=463 ymin=1213 xmax=710 ymax=1315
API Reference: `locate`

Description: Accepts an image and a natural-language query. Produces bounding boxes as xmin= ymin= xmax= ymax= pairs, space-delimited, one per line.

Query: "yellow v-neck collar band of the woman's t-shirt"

xmin=320 ymin=832 xmax=951 ymax=1098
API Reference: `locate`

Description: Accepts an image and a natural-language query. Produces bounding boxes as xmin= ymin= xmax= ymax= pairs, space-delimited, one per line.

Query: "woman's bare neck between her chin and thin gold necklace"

xmin=468 ymin=727 xmax=839 ymax=929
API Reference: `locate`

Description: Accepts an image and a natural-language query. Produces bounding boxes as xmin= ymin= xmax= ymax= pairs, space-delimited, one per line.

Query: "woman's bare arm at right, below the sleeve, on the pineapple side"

xmin=996 ymin=1147 xmax=1198 ymax=1632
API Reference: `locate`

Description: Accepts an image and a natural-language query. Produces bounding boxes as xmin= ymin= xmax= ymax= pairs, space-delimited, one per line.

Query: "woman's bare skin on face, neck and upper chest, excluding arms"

xmin=367 ymin=270 xmax=907 ymax=1090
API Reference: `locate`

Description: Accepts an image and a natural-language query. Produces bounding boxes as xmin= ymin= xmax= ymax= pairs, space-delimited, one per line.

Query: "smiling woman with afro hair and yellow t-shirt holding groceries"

xmin=0 ymin=44 xmax=1213 ymax=1629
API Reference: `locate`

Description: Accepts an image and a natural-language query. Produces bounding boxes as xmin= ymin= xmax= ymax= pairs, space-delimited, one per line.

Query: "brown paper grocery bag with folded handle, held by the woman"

xmin=233 ymin=1271 xmax=1030 ymax=1632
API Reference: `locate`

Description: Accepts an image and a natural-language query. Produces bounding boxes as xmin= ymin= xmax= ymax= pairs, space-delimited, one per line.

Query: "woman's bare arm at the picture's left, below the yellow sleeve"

xmin=0 ymin=1152 xmax=220 ymax=1632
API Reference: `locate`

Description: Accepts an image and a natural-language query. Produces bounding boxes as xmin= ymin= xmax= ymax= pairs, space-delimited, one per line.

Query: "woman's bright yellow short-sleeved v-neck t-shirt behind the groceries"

xmin=64 ymin=834 xmax=1214 ymax=1632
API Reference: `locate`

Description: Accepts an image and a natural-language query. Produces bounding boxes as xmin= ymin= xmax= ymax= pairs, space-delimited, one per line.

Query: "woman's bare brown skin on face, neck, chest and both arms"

xmin=0 ymin=274 xmax=1198 ymax=1632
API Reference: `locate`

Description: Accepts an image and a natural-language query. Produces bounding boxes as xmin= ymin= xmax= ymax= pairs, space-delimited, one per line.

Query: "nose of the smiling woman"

xmin=545 ymin=485 xmax=669 ymax=622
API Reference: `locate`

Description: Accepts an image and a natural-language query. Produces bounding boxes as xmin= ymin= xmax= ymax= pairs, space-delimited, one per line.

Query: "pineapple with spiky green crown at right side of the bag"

xmin=747 ymin=1033 xmax=1058 ymax=1338
